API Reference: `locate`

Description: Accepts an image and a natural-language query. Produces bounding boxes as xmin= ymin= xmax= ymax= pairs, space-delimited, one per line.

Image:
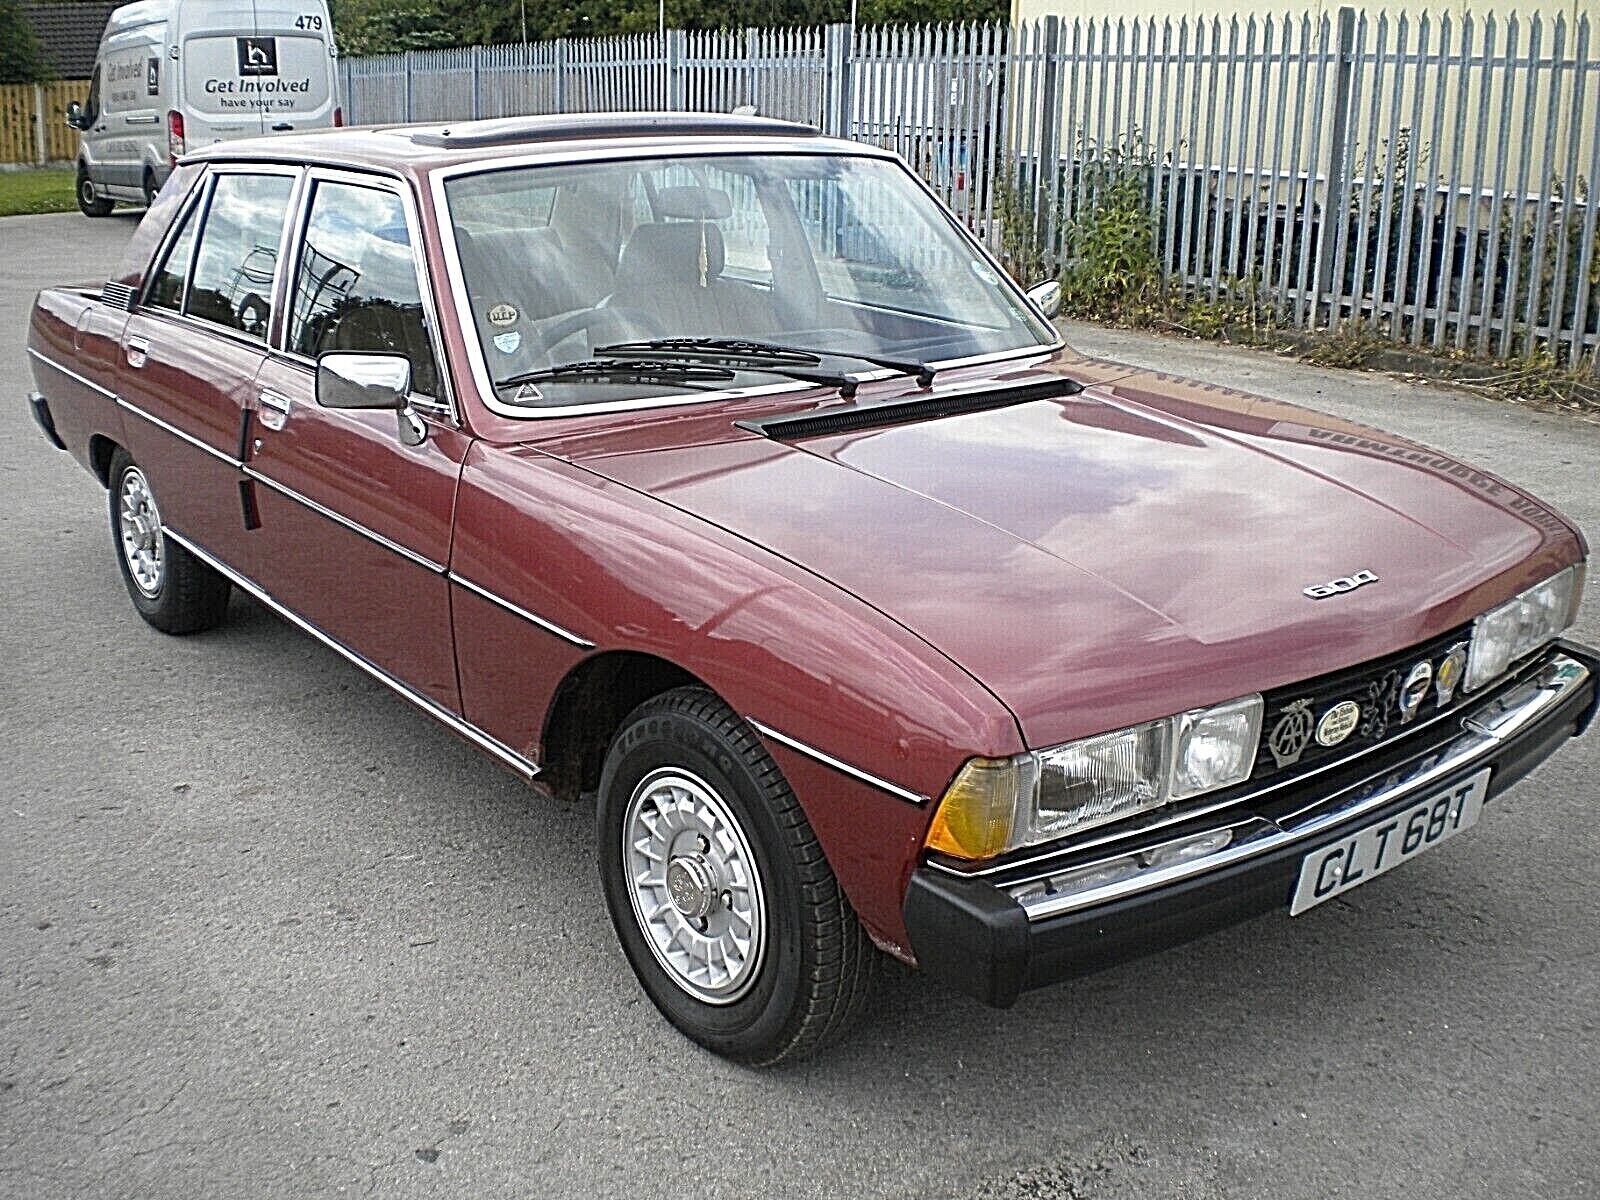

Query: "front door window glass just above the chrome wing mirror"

xmin=288 ymin=182 xmax=438 ymax=395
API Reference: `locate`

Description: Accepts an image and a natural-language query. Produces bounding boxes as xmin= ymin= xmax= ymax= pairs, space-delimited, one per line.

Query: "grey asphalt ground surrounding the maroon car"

xmin=9 ymin=214 xmax=1600 ymax=1200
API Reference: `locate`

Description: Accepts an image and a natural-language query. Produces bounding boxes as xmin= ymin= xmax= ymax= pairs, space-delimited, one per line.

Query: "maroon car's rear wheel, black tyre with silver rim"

xmin=110 ymin=450 xmax=229 ymax=634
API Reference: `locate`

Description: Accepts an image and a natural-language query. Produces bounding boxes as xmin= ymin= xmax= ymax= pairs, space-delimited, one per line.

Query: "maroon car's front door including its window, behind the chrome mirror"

xmin=245 ymin=173 xmax=469 ymax=712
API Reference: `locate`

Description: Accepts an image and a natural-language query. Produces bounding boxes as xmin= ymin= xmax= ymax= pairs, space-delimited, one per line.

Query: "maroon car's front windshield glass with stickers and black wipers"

xmin=445 ymin=154 xmax=1054 ymax=410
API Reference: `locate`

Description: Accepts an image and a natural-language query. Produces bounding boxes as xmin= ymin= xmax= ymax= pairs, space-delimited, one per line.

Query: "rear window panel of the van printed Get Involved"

xmin=184 ymin=34 xmax=330 ymax=115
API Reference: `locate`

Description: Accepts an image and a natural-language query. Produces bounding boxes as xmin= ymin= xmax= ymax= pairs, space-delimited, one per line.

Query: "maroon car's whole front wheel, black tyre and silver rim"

xmin=597 ymin=688 xmax=877 ymax=1066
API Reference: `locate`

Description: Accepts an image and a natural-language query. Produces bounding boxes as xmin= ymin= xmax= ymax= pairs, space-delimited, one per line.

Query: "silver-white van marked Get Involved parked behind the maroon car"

xmin=67 ymin=0 xmax=342 ymax=216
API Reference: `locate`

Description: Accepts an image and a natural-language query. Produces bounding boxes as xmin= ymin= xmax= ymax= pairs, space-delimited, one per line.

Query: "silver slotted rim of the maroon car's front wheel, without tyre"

xmin=622 ymin=768 xmax=766 ymax=1005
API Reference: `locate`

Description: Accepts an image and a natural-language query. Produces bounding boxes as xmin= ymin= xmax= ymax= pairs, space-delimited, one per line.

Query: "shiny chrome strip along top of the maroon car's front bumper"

xmin=998 ymin=653 xmax=1589 ymax=922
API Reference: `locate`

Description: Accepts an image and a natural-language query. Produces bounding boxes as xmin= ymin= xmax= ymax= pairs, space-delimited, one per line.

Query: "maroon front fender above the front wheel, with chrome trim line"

xmin=451 ymin=443 xmax=1022 ymax=946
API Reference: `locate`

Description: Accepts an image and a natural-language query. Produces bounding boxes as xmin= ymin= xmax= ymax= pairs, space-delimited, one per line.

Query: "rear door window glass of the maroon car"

xmin=184 ymin=174 xmax=294 ymax=341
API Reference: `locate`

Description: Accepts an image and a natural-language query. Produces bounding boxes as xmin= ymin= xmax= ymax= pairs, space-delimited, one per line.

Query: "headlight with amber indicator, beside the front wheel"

xmin=926 ymin=696 xmax=1261 ymax=859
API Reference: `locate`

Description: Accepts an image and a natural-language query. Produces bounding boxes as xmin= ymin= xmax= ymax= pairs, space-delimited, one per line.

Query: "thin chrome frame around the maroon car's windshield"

xmin=429 ymin=138 xmax=1066 ymax=421
